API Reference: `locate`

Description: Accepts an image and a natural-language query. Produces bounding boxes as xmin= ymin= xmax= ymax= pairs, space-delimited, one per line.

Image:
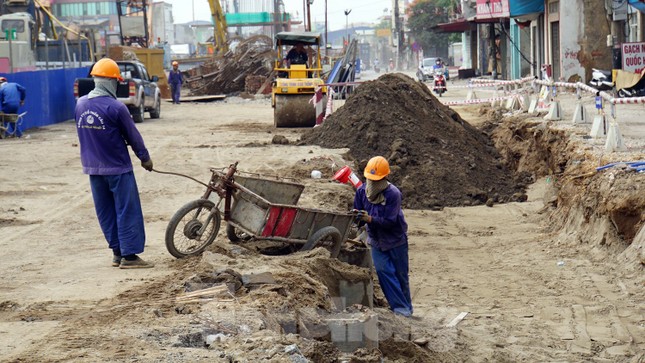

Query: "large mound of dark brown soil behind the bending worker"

xmin=302 ymin=73 xmax=525 ymax=208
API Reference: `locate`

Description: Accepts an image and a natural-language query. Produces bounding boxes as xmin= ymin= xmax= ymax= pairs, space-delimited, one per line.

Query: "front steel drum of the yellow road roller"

xmin=273 ymin=94 xmax=316 ymax=127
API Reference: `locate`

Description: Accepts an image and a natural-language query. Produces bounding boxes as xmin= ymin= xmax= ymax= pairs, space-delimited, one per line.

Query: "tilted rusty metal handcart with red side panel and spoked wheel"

xmin=166 ymin=163 xmax=354 ymax=258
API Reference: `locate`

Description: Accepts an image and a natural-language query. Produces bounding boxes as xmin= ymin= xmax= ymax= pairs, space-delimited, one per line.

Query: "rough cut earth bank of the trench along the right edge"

xmin=481 ymin=110 xmax=645 ymax=269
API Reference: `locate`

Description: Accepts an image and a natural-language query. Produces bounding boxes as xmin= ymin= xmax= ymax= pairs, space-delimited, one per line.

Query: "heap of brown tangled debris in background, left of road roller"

xmin=187 ymin=35 xmax=275 ymax=96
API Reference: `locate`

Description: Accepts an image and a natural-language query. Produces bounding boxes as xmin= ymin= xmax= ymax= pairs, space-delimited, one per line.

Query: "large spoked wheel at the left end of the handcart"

xmin=166 ymin=199 xmax=221 ymax=258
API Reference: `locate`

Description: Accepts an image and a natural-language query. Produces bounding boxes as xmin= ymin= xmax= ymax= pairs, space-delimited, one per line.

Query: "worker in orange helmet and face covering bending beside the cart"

xmin=354 ymin=156 xmax=413 ymax=317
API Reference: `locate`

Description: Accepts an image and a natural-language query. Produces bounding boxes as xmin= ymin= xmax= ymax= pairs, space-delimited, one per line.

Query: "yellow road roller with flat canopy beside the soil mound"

xmin=271 ymin=32 xmax=327 ymax=127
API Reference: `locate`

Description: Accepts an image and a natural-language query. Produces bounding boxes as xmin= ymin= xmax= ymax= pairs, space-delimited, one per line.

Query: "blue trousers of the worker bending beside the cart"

xmin=372 ymin=243 xmax=413 ymax=316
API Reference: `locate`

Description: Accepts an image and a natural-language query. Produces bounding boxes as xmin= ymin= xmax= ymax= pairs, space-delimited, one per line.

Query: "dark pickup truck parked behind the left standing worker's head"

xmin=74 ymin=61 xmax=161 ymax=123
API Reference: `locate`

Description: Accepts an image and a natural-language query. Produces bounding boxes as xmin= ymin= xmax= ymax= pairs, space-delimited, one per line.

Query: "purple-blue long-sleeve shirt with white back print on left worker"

xmin=74 ymin=96 xmax=150 ymax=175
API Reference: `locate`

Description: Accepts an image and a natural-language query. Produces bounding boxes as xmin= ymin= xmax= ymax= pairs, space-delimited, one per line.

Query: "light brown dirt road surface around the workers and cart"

xmin=0 ymin=78 xmax=645 ymax=363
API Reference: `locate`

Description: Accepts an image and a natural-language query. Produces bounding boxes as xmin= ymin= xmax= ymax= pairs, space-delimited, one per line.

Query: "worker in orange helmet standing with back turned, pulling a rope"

xmin=74 ymin=58 xmax=154 ymax=269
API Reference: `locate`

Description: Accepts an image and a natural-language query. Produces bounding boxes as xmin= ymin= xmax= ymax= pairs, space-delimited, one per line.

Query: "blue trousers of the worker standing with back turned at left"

xmin=90 ymin=171 xmax=146 ymax=256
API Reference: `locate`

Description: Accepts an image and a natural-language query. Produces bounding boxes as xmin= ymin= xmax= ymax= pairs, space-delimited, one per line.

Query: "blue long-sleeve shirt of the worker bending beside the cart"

xmin=354 ymin=184 xmax=408 ymax=251
